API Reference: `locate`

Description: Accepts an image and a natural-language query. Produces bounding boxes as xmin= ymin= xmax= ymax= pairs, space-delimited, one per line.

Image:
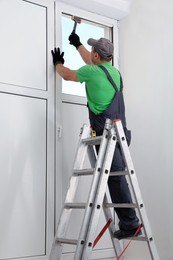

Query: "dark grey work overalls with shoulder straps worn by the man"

xmin=88 ymin=66 xmax=139 ymax=230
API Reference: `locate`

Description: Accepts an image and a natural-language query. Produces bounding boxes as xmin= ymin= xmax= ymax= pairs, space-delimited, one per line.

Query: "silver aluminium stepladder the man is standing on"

xmin=49 ymin=119 xmax=159 ymax=260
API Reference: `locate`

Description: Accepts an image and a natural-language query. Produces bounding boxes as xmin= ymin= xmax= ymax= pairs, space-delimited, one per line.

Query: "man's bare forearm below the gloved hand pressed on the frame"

xmin=56 ymin=64 xmax=79 ymax=82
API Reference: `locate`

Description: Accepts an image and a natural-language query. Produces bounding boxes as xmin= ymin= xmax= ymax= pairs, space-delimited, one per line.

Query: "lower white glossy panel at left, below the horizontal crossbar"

xmin=0 ymin=93 xmax=46 ymax=259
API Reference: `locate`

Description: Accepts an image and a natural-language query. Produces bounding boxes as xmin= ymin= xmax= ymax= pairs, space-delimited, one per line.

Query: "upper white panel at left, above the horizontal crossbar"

xmin=0 ymin=0 xmax=46 ymax=90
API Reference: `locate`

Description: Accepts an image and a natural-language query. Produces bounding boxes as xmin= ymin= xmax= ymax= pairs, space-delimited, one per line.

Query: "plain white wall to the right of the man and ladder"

xmin=120 ymin=0 xmax=173 ymax=260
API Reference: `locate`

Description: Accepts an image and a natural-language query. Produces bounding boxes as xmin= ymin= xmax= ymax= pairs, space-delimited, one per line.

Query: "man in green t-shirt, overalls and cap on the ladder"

xmin=51 ymin=33 xmax=141 ymax=239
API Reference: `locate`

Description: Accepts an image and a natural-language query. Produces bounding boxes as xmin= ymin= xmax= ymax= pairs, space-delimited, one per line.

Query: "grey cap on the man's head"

xmin=87 ymin=38 xmax=114 ymax=59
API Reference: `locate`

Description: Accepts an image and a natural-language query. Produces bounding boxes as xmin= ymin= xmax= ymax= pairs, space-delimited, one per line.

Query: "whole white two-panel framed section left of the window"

xmin=0 ymin=0 xmax=55 ymax=260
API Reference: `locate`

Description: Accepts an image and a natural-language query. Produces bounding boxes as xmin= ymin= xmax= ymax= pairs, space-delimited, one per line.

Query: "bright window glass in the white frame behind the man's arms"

xmin=62 ymin=14 xmax=109 ymax=97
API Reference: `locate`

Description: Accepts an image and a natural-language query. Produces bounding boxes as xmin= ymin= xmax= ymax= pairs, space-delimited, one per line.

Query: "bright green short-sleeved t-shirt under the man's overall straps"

xmin=76 ymin=62 xmax=120 ymax=115
